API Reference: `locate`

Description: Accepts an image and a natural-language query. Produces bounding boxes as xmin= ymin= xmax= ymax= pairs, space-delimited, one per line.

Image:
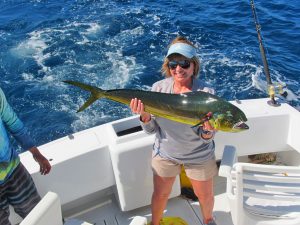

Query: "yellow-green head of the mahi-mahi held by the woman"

xmin=210 ymin=109 xmax=249 ymax=132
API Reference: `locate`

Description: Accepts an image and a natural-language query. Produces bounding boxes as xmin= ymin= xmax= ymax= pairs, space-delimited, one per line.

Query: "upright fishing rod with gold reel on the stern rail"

xmin=250 ymin=0 xmax=287 ymax=106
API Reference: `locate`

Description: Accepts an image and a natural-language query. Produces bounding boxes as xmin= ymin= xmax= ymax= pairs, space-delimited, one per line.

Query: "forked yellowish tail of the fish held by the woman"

xmin=63 ymin=80 xmax=105 ymax=112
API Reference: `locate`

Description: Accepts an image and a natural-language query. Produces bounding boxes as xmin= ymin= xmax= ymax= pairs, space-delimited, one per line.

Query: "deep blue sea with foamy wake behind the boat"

xmin=0 ymin=0 xmax=300 ymax=145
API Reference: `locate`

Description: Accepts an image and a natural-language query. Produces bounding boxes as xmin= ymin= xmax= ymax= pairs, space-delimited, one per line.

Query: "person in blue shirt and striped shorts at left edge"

xmin=0 ymin=88 xmax=51 ymax=225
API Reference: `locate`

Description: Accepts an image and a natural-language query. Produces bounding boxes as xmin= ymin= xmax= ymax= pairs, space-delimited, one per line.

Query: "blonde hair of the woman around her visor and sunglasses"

xmin=161 ymin=36 xmax=200 ymax=77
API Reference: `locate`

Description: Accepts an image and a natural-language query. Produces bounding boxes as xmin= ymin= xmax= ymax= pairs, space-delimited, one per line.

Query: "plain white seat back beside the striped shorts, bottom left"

xmin=20 ymin=192 xmax=92 ymax=225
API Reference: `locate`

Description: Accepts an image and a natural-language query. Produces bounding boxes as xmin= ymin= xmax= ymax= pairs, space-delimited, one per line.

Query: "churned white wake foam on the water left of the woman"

xmin=12 ymin=19 xmax=148 ymax=132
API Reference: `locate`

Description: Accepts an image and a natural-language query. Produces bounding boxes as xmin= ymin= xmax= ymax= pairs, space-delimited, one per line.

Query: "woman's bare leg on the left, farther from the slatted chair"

xmin=151 ymin=174 xmax=176 ymax=225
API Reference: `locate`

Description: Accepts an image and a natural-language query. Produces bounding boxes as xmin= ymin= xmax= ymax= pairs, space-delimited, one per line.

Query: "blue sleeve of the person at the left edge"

xmin=0 ymin=88 xmax=35 ymax=151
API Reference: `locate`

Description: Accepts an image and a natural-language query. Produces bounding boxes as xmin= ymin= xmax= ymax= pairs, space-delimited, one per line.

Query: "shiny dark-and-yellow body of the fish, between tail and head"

xmin=104 ymin=89 xmax=217 ymax=125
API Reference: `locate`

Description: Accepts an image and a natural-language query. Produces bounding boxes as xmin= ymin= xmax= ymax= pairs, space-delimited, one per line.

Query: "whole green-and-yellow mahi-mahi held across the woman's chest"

xmin=64 ymin=80 xmax=249 ymax=132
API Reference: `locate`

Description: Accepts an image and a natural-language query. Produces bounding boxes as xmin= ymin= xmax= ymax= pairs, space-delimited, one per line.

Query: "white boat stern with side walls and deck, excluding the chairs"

xmin=10 ymin=98 xmax=300 ymax=225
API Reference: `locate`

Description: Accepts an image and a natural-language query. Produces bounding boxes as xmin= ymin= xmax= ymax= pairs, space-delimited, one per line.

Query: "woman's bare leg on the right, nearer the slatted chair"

xmin=190 ymin=178 xmax=214 ymax=224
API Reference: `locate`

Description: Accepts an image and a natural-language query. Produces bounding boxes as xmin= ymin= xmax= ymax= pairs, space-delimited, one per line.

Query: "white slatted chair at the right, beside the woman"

xmin=219 ymin=146 xmax=300 ymax=225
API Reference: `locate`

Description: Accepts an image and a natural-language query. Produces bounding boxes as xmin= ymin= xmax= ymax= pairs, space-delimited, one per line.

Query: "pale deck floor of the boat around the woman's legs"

xmin=70 ymin=177 xmax=233 ymax=225
